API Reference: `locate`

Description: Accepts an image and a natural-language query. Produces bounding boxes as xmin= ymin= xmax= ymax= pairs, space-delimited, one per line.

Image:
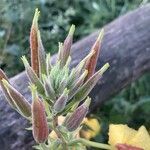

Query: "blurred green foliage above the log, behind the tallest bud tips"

xmin=0 ymin=0 xmax=145 ymax=76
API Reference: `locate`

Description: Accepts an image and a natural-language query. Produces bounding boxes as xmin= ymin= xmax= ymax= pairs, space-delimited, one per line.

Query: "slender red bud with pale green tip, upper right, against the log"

xmin=85 ymin=29 xmax=104 ymax=81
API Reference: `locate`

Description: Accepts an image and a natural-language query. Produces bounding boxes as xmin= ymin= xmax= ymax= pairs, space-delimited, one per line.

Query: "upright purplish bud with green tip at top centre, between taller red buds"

xmin=61 ymin=25 xmax=75 ymax=66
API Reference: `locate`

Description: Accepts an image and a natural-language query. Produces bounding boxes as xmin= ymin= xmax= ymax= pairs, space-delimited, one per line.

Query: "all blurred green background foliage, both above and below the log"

xmin=0 ymin=0 xmax=150 ymax=147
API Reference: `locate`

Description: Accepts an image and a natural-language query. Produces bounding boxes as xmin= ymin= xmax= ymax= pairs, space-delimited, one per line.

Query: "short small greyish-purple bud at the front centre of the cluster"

xmin=54 ymin=89 xmax=69 ymax=112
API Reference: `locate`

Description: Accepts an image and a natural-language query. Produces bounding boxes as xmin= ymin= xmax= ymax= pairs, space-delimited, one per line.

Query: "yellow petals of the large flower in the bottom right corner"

xmin=109 ymin=124 xmax=150 ymax=150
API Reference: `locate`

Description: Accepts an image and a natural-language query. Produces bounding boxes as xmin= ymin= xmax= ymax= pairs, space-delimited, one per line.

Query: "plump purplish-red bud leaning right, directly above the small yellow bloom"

xmin=64 ymin=97 xmax=91 ymax=132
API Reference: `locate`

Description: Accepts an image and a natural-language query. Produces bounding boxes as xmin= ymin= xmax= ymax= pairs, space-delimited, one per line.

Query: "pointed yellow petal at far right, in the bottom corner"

xmin=129 ymin=126 xmax=150 ymax=150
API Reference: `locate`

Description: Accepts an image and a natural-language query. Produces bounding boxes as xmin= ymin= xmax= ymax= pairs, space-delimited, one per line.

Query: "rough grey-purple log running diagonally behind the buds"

xmin=0 ymin=5 xmax=150 ymax=150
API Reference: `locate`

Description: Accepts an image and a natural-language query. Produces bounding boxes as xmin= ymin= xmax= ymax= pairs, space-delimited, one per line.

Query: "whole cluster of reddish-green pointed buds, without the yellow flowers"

xmin=0 ymin=9 xmax=109 ymax=149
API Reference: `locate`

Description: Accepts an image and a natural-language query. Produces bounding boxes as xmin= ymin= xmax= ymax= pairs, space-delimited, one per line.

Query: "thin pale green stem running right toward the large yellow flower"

xmin=69 ymin=138 xmax=111 ymax=150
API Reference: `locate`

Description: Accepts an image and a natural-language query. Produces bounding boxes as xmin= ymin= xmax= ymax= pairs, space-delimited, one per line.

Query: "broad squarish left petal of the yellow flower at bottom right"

xmin=108 ymin=124 xmax=137 ymax=147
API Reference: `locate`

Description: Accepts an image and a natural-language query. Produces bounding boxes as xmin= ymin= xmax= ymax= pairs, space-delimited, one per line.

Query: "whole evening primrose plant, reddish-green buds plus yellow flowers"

xmin=0 ymin=9 xmax=150 ymax=150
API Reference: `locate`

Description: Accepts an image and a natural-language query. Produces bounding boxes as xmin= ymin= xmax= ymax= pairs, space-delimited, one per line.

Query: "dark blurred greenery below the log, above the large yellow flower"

xmin=94 ymin=73 xmax=150 ymax=146
